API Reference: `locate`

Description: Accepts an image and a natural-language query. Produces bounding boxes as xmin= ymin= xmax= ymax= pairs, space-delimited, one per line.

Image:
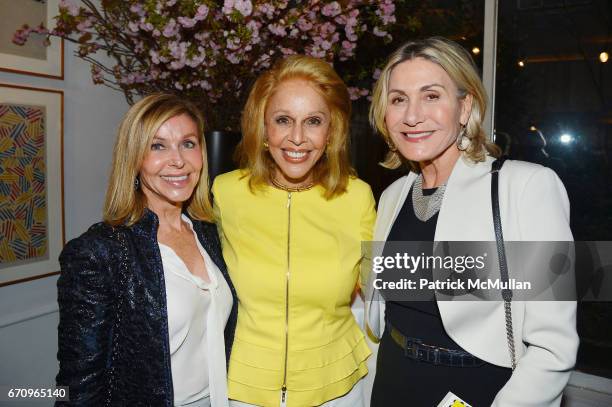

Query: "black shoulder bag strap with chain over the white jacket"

xmin=491 ymin=157 xmax=516 ymax=370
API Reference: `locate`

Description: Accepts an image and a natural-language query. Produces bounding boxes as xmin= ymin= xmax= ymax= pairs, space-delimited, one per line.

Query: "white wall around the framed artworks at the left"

xmin=0 ymin=35 xmax=128 ymax=406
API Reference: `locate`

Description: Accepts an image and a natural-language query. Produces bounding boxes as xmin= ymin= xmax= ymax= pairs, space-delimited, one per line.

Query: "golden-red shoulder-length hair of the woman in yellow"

xmin=236 ymin=55 xmax=355 ymax=199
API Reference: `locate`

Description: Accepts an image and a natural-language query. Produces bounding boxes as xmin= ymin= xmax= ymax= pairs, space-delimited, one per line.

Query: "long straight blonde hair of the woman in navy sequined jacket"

xmin=103 ymin=94 xmax=213 ymax=226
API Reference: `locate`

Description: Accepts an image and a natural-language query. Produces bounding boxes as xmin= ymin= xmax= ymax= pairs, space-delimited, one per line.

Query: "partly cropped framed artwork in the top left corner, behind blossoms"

xmin=0 ymin=0 xmax=64 ymax=79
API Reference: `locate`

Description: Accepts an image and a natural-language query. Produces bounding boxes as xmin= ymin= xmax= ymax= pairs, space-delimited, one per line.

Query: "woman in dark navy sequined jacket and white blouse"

xmin=56 ymin=94 xmax=236 ymax=407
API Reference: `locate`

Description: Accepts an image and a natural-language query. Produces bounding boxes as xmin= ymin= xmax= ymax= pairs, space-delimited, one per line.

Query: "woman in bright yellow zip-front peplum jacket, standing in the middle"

xmin=213 ymin=56 xmax=375 ymax=407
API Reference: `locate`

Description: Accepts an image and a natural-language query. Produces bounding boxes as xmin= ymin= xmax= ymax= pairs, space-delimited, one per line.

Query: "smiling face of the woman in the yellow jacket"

xmin=265 ymin=79 xmax=330 ymax=186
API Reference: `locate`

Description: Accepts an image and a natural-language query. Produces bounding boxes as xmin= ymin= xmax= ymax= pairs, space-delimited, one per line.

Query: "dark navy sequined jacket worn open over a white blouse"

xmin=56 ymin=210 xmax=237 ymax=407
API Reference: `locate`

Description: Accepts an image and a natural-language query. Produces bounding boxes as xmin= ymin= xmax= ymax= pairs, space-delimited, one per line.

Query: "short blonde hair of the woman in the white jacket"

xmin=370 ymin=37 xmax=500 ymax=171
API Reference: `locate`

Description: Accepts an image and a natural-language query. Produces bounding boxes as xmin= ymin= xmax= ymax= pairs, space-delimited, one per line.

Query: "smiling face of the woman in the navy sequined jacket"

xmin=139 ymin=114 xmax=202 ymax=212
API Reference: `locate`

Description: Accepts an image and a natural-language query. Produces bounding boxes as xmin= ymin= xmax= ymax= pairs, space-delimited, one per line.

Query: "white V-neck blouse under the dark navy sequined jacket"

xmin=159 ymin=215 xmax=232 ymax=407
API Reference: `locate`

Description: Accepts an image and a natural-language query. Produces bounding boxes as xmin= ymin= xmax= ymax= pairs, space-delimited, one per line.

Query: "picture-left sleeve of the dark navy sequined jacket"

xmin=56 ymin=237 xmax=112 ymax=406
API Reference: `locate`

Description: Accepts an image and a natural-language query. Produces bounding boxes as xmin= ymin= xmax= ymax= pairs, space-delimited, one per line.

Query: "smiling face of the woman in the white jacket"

xmin=385 ymin=58 xmax=472 ymax=165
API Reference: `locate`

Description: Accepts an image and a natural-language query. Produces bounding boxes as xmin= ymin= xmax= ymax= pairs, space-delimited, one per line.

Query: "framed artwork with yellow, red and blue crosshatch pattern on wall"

xmin=0 ymin=83 xmax=65 ymax=287
